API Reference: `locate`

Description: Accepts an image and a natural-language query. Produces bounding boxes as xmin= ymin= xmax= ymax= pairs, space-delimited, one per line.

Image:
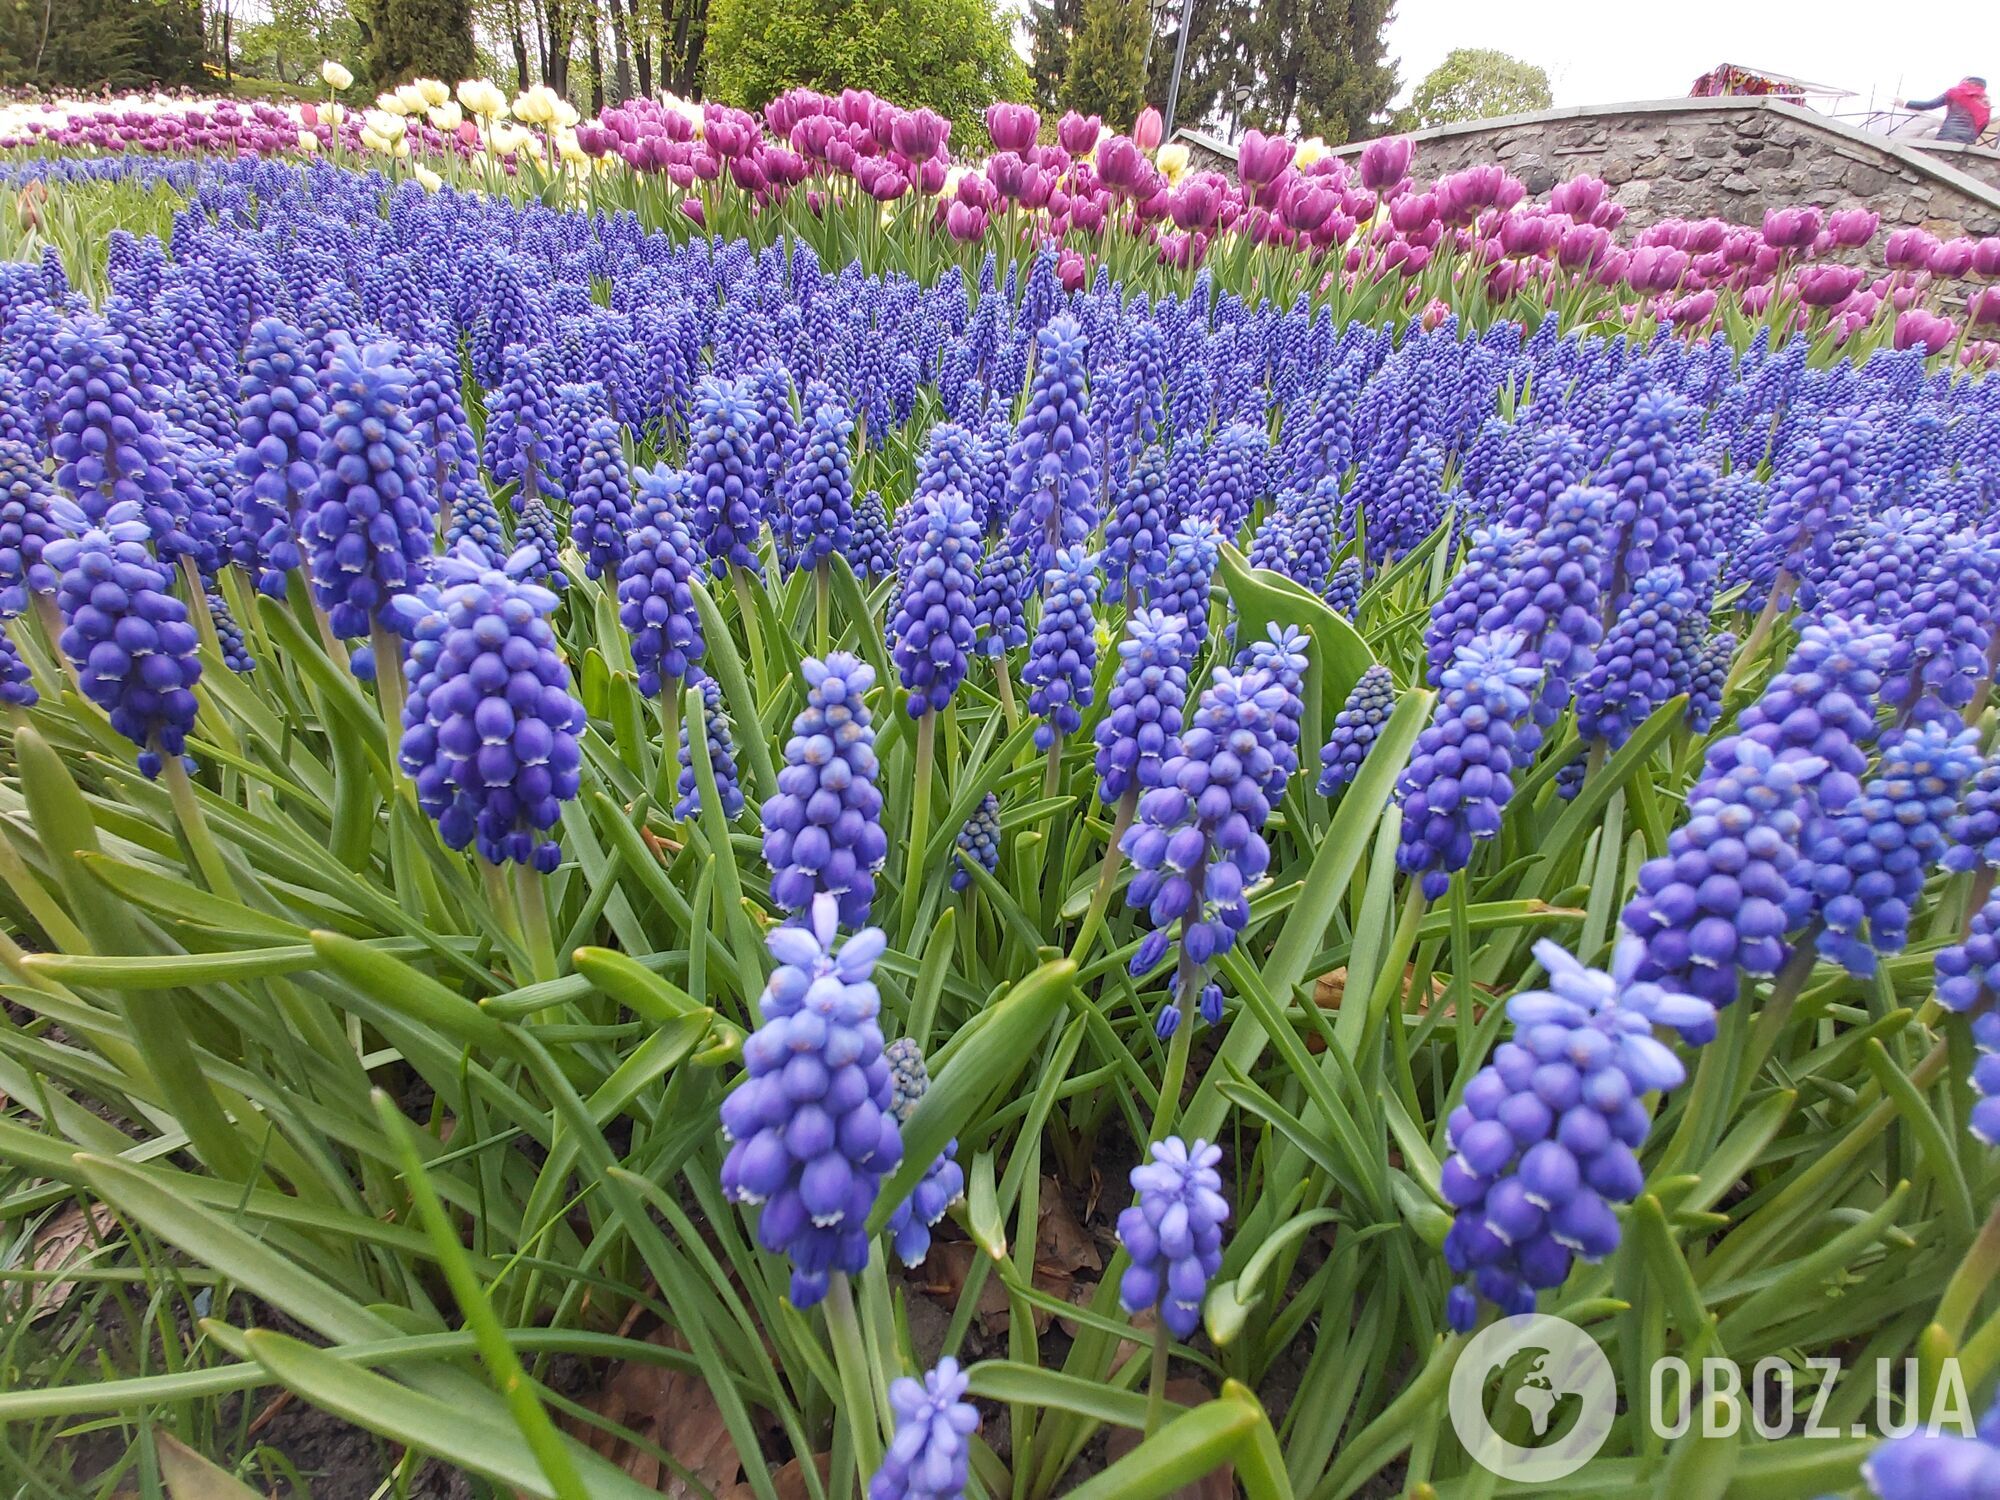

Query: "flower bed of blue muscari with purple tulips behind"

xmin=0 ymin=126 xmax=2000 ymax=1500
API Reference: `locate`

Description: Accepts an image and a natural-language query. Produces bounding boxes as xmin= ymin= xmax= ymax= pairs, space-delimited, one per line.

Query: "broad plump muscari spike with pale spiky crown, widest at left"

xmin=386 ymin=548 xmax=586 ymax=874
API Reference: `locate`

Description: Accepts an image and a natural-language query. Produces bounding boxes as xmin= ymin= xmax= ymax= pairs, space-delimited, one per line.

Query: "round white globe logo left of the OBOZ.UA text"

xmin=1448 ymin=1312 xmax=1618 ymax=1484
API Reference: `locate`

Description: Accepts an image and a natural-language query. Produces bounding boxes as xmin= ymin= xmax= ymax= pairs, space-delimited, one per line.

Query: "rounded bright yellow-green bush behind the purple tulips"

xmin=708 ymin=0 xmax=1028 ymax=130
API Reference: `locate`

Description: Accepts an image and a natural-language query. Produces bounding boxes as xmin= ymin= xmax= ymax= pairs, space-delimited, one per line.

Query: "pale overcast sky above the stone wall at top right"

xmin=1388 ymin=0 xmax=2000 ymax=110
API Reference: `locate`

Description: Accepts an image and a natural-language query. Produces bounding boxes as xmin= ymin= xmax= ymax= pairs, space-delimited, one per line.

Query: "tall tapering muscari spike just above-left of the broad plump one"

xmin=298 ymin=344 xmax=436 ymax=636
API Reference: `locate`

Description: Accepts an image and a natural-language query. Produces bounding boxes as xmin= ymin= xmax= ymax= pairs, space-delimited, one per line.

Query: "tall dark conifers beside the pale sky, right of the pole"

xmin=1146 ymin=0 xmax=1396 ymax=144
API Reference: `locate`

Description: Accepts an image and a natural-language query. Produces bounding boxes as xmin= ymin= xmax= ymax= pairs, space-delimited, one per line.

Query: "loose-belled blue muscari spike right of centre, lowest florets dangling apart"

xmin=1120 ymin=668 xmax=1284 ymax=988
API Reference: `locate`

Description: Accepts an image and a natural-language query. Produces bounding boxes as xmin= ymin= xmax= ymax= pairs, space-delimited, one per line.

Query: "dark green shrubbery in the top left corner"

xmin=0 ymin=0 xmax=206 ymax=88
